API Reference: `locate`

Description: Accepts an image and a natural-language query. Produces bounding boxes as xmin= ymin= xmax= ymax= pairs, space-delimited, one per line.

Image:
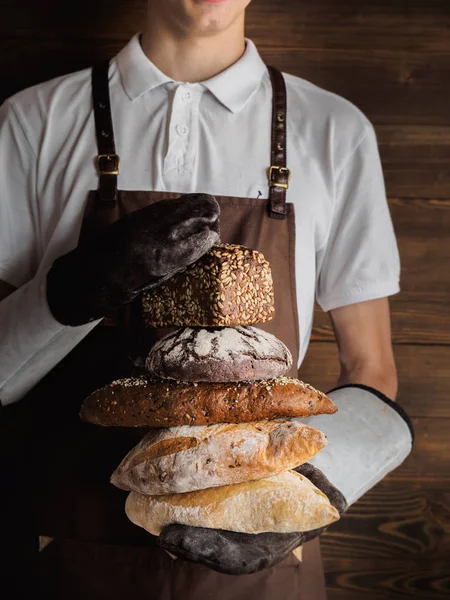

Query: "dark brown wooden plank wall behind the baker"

xmin=0 ymin=0 xmax=450 ymax=600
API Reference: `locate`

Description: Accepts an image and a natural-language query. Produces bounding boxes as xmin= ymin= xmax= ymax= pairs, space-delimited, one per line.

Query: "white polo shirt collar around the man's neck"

xmin=116 ymin=34 xmax=267 ymax=113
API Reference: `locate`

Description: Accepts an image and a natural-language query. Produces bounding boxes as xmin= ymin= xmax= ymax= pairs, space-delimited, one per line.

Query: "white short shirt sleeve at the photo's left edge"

xmin=0 ymin=100 xmax=39 ymax=287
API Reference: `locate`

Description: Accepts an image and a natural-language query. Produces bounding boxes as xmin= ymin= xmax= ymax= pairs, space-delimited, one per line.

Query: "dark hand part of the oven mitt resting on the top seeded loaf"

xmin=47 ymin=194 xmax=220 ymax=325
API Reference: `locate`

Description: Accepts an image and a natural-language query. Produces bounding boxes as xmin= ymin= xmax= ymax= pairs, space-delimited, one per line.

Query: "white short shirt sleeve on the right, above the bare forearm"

xmin=316 ymin=121 xmax=400 ymax=311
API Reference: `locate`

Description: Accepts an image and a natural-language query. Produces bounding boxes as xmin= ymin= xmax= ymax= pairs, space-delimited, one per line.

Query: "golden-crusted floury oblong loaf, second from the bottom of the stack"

xmin=111 ymin=420 xmax=327 ymax=496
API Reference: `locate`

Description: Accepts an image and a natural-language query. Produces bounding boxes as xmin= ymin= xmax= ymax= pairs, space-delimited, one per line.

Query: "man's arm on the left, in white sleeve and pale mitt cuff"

xmin=0 ymin=100 xmax=104 ymax=405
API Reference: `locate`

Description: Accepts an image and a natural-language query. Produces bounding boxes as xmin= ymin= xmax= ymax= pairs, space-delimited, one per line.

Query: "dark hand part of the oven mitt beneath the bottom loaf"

xmin=158 ymin=463 xmax=346 ymax=575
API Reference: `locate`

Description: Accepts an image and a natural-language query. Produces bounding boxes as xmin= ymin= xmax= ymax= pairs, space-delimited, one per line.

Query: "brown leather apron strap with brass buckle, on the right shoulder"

xmin=267 ymin=66 xmax=291 ymax=219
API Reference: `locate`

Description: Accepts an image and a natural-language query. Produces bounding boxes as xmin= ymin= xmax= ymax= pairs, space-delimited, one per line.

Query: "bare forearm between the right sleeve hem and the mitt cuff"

xmin=330 ymin=298 xmax=397 ymax=400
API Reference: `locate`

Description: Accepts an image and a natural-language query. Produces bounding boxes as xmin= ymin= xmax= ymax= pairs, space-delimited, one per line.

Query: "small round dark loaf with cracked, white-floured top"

xmin=146 ymin=326 xmax=292 ymax=381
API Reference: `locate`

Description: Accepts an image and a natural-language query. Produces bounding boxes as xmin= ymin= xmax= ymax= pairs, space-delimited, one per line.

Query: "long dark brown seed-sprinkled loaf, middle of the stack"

xmin=80 ymin=375 xmax=337 ymax=427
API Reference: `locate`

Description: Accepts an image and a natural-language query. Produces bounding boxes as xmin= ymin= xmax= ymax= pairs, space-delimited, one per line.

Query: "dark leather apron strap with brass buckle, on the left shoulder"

xmin=92 ymin=60 xmax=120 ymax=206
